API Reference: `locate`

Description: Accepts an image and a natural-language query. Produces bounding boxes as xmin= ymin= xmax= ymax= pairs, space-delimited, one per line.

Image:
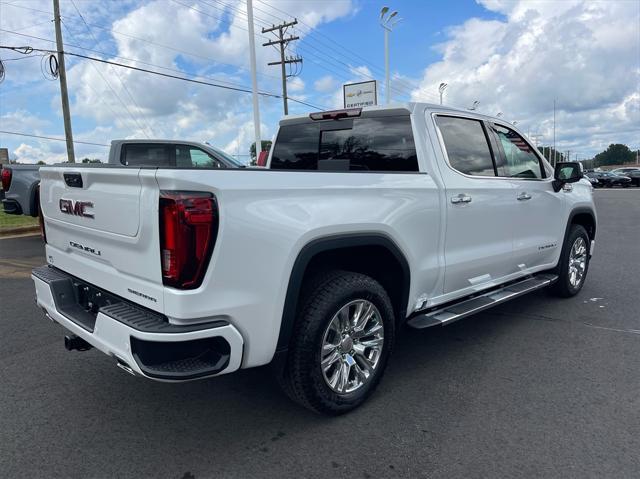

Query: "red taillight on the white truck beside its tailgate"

xmin=160 ymin=191 xmax=218 ymax=289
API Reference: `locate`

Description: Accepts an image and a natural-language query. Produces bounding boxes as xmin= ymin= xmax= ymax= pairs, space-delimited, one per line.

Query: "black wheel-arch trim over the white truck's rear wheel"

xmin=276 ymin=233 xmax=411 ymax=353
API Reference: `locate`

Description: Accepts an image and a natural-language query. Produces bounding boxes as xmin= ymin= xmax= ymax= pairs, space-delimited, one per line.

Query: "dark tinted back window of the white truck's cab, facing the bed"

xmin=271 ymin=115 xmax=418 ymax=172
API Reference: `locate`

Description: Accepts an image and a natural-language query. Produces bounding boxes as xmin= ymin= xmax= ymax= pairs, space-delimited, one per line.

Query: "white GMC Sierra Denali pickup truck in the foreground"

xmin=32 ymin=103 xmax=596 ymax=414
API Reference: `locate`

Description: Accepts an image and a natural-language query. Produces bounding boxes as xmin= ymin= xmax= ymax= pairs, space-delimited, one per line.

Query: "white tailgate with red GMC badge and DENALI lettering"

xmin=40 ymin=166 xmax=163 ymax=312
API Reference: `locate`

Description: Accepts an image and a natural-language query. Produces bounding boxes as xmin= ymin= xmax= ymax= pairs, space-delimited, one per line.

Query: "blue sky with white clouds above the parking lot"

xmin=0 ymin=0 xmax=640 ymax=162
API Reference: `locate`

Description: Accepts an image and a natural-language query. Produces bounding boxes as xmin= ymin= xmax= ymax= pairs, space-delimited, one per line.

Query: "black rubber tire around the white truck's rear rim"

xmin=279 ymin=271 xmax=395 ymax=415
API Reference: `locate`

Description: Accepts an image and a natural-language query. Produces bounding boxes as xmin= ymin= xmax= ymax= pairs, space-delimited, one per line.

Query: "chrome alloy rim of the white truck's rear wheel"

xmin=321 ymin=299 xmax=384 ymax=394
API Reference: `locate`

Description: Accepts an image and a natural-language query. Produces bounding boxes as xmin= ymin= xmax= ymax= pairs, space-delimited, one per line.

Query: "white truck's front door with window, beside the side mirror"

xmin=490 ymin=123 xmax=572 ymax=270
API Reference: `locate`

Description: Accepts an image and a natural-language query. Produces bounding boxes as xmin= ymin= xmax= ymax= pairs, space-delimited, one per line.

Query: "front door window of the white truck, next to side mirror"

xmin=491 ymin=124 xmax=544 ymax=179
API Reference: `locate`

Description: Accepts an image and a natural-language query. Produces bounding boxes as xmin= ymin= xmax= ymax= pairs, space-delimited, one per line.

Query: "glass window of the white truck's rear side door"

xmin=436 ymin=116 xmax=496 ymax=176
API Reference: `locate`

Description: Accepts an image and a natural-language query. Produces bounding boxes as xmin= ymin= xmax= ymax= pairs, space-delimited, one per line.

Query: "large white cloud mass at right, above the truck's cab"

xmin=412 ymin=0 xmax=640 ymax=154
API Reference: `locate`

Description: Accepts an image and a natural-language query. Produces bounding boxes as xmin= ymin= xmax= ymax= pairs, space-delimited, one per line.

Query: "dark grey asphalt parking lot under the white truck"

xmin=0 ymin=189 xmax=640 ymax=479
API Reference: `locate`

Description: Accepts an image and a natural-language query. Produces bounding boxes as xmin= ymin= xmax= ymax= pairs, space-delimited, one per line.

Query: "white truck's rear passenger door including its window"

xmin=434 ymin=114 xmax=514 ymax=295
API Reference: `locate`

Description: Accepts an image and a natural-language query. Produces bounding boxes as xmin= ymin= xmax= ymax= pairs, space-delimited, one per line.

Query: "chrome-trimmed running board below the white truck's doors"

xmin=407 ymin=274 xmax=558 ymax=329
